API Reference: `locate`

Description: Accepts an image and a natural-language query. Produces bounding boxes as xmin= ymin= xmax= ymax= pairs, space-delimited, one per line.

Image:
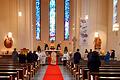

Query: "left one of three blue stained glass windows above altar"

xmin=36 ymin=0 xmax=40 ymax=40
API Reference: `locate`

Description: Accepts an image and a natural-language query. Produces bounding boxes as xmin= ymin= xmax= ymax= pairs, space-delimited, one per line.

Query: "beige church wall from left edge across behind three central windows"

xmin=0 ymin=0 xmax=74 ymax=51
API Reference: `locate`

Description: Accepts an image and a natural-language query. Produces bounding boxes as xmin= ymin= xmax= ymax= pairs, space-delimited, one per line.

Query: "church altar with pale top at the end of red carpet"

xmin=45 ymin=50 xmax=61 ymax=65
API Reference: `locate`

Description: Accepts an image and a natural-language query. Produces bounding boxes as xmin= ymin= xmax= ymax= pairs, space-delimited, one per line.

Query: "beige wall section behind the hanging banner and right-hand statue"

xmin=79 ymin=0 xmax=108 ymax=57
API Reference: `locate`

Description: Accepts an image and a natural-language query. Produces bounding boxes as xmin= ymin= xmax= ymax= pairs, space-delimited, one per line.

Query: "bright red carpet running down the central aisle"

xmin=43 ymin=65 xmax=64 ymax=80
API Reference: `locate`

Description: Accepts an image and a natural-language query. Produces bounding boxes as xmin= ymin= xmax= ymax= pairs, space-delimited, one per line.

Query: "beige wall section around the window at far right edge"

xmin=107 ymin=0 xmax=120 ymax=60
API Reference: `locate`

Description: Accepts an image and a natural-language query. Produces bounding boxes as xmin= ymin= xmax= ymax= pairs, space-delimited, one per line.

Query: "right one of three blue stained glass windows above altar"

xmin=64 ymin=0 xmax=70 ymax=40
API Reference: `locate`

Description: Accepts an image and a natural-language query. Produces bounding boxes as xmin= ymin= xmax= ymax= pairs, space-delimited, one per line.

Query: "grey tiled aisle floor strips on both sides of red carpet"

xmin=34 ymin=65 xmax=74 ymax=80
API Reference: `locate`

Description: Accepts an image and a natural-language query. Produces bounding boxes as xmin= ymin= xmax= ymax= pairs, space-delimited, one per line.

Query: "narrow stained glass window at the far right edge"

xmin=113 ymin=0 xmax=119 ymax=31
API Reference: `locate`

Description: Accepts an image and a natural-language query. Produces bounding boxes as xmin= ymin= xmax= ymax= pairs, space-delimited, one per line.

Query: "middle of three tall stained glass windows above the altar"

xmin=49 ymin=0 xmax=56 ymax=41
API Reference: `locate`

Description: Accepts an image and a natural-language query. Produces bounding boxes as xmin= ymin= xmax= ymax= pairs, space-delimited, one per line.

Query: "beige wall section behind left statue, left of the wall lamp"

xmin=0 ymin=0 xmax=18 ymax=51
